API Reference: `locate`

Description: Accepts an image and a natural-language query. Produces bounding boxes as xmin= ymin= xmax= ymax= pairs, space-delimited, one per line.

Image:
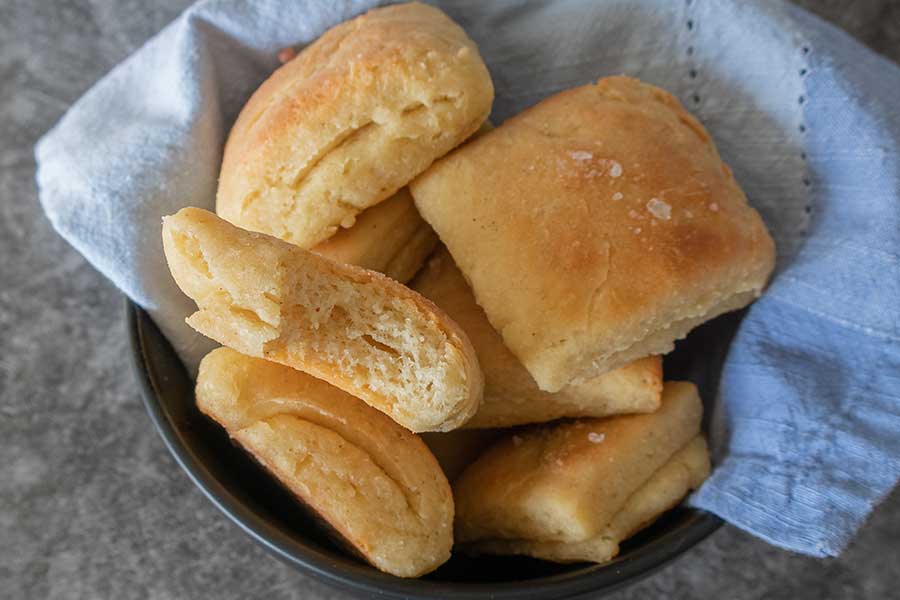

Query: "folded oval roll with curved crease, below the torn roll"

xmin=197 ymin=348 xmax=453 ymax=577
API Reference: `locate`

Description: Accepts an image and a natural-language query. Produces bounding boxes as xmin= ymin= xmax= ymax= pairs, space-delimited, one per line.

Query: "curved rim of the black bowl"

xmin=124 ymin=298 xmax=723 ymax=600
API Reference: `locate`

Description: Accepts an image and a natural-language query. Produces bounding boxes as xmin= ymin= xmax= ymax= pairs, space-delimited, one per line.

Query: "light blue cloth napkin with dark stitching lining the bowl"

xmin=31 ymin=0 xmax=900 ymax=556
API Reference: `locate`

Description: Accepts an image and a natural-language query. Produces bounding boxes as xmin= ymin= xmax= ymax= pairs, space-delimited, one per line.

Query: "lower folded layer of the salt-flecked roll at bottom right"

xmin=464 ymin=435 xmax=709 ymax=563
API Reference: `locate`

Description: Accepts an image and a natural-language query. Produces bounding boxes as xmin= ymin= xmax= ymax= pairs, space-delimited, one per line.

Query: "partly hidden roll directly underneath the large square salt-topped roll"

xmin=410 ymin=247 xmax=662 ymax=428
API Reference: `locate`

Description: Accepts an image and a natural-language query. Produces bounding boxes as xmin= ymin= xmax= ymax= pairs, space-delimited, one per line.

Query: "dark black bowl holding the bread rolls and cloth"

xmin=126 ymin=302 xmax=728 ymax=600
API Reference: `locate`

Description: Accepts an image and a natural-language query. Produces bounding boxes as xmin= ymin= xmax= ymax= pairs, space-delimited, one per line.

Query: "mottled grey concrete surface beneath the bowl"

xmin=0 ymin=0 xmax=900 ymax=600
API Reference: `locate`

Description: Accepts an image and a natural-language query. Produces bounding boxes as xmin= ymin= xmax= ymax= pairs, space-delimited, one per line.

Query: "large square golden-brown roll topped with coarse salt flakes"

xmin=410 ymin=77 xmax=774 ymax=392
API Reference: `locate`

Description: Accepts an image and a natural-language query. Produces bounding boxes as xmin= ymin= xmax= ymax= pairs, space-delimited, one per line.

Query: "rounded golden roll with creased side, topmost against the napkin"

xmin=216 ymin=3 xmax=494 ymax=248
